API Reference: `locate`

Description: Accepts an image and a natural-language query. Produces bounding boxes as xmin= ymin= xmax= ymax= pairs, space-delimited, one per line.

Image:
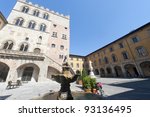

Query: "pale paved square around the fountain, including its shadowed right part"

xmin=0 ymin=78 xmax=150 ymax=100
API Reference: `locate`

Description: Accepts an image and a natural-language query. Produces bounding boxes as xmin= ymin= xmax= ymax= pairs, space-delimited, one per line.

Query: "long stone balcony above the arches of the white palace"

xmin=0 ymin=49 xmax=45 ymax=61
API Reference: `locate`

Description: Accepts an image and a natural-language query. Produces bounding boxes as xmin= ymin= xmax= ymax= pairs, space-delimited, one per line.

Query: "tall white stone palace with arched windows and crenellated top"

xmin=0 ymin=0 xmax=70 ymax=82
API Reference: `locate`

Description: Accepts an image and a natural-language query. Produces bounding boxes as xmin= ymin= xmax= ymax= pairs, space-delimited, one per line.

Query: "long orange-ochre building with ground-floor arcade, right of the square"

xmin=85 ymin=23 xmax=150 ymax=77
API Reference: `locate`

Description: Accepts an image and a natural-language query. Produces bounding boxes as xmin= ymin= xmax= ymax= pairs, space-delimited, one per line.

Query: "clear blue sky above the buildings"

xmin=0 ymin=0 xmax=150 ymax=55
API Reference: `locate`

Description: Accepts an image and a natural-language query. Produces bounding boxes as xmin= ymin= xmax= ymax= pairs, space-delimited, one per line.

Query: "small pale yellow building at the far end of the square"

xmin=69 ymin=54 xmax=85 ymax=73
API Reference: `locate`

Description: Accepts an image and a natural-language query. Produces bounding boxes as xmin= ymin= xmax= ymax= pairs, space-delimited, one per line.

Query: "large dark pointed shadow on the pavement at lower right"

xmin=107 ymin=79 xmax=150 ymax=100
